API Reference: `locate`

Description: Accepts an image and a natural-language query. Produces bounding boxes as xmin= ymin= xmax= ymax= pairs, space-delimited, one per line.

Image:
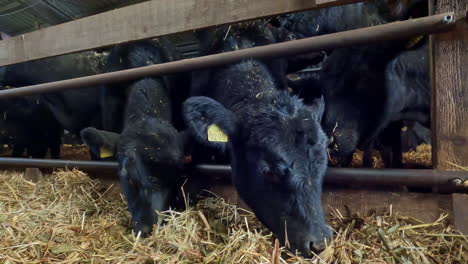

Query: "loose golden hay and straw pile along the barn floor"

xmin=0 ymin=171 xmax=468 ymax=264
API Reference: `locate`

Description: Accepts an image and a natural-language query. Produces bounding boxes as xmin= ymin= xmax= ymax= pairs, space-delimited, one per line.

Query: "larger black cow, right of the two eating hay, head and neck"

xmin=184 ymin=25 xmax=332 ymax=255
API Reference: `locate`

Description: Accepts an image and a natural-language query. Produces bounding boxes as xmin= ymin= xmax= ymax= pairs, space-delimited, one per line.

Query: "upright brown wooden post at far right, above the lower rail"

xmin=431 ymin=0 xmax=468 ymax=170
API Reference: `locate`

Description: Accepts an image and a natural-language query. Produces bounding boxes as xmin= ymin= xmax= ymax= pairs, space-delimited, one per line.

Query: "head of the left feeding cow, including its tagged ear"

xmin=81 ymin=118 xmax=183 ymax=236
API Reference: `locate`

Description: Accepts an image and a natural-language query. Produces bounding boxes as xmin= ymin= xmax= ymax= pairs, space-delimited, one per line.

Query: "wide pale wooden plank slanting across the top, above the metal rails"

xmin=0 ymin=0 xmax=362 ymax=66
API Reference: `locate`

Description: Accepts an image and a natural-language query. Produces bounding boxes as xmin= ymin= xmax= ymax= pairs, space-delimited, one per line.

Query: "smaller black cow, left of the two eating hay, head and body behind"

xmin=81 ymin=40 xmax=189 ymax=236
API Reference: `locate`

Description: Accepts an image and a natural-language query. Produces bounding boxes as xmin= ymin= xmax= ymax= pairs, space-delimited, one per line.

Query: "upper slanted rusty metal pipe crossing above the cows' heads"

xmin=0 ymin=12 xmax=455 ymax=98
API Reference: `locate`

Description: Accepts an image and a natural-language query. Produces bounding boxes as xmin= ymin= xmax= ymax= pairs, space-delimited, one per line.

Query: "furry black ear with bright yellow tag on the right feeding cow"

xmin=183 ymin=96 xmax=239 ymax=148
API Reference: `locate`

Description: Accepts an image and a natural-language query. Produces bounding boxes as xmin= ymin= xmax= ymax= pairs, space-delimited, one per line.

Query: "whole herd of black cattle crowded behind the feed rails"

xmin=0 ymin=0 xmax=430 ymax=255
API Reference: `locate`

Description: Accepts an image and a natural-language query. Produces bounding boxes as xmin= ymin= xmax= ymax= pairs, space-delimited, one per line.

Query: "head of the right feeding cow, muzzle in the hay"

xmin=184 ymin=93 xmax=331 ymax=255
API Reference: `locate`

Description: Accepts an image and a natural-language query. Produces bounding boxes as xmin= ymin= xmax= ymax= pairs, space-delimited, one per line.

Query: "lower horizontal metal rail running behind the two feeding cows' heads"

xmin=0 ymin=158 xmax=468 ymax=193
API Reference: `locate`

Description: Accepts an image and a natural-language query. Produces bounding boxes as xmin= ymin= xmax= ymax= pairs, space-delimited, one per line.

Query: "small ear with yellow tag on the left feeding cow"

xmin=80 ymin=127 xmax=119 ymax=159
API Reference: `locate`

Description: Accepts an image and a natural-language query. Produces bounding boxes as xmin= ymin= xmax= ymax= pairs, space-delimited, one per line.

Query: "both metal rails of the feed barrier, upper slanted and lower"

xmin=0 ymin=13 xmax=468 ymax=192
